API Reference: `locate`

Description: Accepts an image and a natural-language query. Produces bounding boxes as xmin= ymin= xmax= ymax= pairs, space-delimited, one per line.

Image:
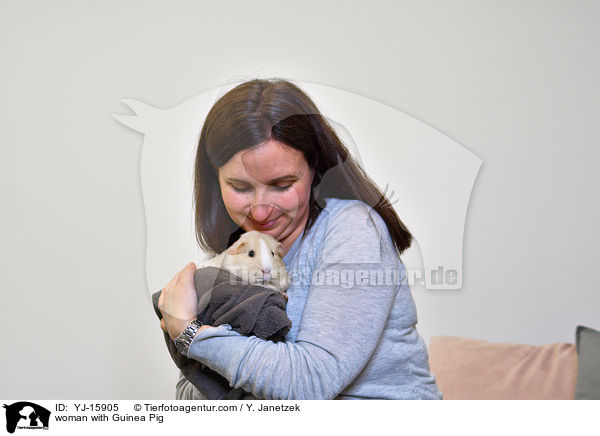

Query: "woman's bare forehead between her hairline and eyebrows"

xmin=219 ymin=141 xmax=308 ymax=183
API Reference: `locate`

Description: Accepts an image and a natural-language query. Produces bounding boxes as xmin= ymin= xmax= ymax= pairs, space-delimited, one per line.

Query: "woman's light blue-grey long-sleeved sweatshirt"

xmin=177 ymin=198 xmax=442 ymax=399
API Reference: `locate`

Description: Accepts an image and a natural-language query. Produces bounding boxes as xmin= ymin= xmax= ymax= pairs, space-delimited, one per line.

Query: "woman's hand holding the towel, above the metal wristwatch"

xmin=158 ymin=262 xmax=204 ymax=340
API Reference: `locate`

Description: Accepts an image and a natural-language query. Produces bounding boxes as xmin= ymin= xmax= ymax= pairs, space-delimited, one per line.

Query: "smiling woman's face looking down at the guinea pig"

xmin=218 ymin=141 xmax=314 ymax=253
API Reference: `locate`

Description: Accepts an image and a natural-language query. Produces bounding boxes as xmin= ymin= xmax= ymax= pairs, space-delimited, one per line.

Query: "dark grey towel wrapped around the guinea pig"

xmin=152 ymin=267 xmax=292 ymax=400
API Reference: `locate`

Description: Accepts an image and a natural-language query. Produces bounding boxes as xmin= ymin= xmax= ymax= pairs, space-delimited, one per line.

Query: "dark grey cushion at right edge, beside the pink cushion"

xmin=575 ymin=326 xmax=600 ymax=400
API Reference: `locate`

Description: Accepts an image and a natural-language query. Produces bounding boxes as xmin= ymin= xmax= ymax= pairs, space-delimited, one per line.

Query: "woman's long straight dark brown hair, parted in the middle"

xmin=194 ymin=78 xmax=412 ymax=253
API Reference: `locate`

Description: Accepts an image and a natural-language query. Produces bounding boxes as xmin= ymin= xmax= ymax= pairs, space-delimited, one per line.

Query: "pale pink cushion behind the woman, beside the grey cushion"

xmin=429 ymin=336 xmax=577 ymax=400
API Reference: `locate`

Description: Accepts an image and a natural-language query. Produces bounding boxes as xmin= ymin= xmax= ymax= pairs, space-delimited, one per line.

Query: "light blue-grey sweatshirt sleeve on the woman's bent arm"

xmin=188 ymin=202 xmax=404 ymax=399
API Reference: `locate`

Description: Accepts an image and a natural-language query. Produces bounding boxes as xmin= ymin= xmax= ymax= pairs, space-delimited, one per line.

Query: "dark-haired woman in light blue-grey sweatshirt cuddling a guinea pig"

xmin=159 ymin=79 xmax=442 ymax=399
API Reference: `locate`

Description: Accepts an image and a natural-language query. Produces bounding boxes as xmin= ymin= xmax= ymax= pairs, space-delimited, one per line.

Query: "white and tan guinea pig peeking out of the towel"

xmin=198 ymin=230 xmax=290 ymax=292
